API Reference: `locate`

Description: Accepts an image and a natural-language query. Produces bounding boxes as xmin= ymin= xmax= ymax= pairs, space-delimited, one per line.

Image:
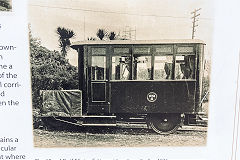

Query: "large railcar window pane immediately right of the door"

xmin=112 ymin=56 xmax=131 ymax=80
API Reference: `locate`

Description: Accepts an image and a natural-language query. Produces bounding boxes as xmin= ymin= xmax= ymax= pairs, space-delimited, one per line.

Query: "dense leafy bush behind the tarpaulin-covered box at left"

xmin=30 ymin=35 xmax=78 ymax=108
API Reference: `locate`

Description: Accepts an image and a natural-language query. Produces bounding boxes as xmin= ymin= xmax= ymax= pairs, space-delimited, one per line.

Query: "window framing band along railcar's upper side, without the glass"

xmin=88 ymin=44 xmax=198 ymax=81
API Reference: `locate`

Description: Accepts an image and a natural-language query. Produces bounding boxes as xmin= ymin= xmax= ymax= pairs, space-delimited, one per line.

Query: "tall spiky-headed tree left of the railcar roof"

xmin=56 ymin=27 xmax=75 ymax=57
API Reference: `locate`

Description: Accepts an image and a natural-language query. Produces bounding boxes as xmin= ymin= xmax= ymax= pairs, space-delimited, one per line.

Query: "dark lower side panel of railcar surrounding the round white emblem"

xmin=110 ymin=81 xmax=195 ymax=113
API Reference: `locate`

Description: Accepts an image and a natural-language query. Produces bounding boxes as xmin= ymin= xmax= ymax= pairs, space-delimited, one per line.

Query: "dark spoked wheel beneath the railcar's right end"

xmin=148 ymin=114 xmax=181 ymax=135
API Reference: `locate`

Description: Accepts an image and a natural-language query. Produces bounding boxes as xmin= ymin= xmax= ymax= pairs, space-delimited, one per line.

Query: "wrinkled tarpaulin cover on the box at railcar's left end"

xmin=41 ymin=90 xmax=82 ymax=117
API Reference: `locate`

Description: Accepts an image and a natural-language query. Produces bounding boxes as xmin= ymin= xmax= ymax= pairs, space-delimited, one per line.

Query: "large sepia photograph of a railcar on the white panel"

xmin=28 ymin=0 xmax=214 ymax=148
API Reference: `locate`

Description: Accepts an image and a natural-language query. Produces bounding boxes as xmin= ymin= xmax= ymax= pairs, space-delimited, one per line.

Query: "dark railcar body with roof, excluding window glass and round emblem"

xmin=72 ymin=40 xmax=204 ymax=114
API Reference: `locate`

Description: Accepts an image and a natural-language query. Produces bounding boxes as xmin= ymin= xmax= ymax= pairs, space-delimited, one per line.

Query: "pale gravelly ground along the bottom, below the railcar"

xmin=33 ymin=126 xmax=207 ymax=148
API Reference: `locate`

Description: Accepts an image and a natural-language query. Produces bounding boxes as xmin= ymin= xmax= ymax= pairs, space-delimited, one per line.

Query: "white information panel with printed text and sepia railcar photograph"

xmin=0 ymin=0 xmax=240 ymax=160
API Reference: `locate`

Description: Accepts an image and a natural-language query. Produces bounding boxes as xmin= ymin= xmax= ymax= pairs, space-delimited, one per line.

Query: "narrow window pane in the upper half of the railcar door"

xmin=91 ymin=56 xmax=106 ymax=80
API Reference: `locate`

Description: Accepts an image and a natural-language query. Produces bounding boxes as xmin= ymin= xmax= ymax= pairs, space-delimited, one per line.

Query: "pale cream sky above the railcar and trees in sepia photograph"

xmin=28 ymin=0 xmax=214 ymax=65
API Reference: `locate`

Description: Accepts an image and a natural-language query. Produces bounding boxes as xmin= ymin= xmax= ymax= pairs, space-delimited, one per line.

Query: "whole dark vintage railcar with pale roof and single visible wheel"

xmin=40 ymin=39 xmax=205 ymax=134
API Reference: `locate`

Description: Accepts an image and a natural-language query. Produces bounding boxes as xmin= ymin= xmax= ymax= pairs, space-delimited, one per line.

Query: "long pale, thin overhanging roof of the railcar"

xmin=71 ymin=39 xmax=205 ymax=48
